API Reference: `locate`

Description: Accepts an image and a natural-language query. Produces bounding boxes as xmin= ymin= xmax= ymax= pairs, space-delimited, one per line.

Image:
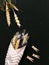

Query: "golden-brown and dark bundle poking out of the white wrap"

xmin=11 ymin=31 xmax=29 ymax=49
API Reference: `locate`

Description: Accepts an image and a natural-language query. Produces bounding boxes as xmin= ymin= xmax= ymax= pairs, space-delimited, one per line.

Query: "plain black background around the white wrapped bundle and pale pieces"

xmin=0 ymin=0 xmax=49 ymax=65
